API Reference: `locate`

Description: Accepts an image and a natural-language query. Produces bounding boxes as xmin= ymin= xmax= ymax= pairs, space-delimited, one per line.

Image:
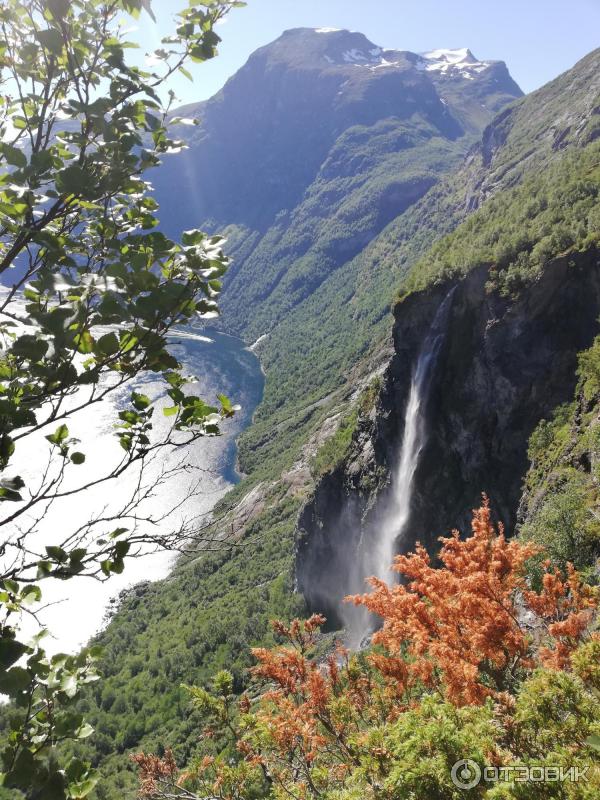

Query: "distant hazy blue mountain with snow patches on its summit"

xmin=156 ymin=29 xmax=521 ymax=352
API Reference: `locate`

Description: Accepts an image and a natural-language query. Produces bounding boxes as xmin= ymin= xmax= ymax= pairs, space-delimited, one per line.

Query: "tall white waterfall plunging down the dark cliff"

xmin=343 ymin=287 xmax=456 ymax=649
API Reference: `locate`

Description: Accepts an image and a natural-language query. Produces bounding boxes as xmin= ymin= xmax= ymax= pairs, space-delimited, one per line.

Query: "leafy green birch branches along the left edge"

xmin=0 ymin=0 xmax=243 ymax=800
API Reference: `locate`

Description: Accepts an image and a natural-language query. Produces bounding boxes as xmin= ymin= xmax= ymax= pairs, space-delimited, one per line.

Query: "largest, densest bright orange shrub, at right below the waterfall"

xmin=349 ymin=498 xmax=595 ymax=705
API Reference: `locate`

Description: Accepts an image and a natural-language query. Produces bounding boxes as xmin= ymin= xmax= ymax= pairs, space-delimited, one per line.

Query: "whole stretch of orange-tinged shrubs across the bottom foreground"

xmin=134 ymin=498 xmax=596 ymax=800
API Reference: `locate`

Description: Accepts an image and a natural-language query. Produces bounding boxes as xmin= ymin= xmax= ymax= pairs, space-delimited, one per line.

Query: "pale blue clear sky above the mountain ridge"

xmin=139 ymin=0 xmax=600 ymax=103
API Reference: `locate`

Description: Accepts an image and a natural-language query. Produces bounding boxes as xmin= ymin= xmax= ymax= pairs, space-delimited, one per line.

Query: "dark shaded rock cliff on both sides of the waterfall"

xmin=296 ymin=250 xmax=600 ymax=624
